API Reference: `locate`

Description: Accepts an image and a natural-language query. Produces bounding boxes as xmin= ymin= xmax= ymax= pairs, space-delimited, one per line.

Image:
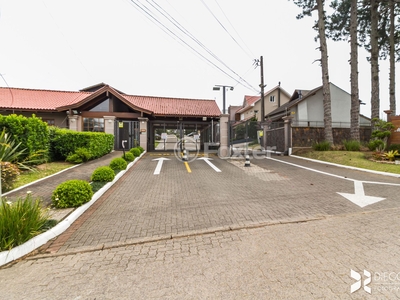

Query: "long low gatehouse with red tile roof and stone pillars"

xmin=0 ymin=83 xmax=221 ymax=150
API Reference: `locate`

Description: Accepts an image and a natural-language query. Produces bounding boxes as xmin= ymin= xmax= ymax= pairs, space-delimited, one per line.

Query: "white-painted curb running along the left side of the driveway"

xmin=0 ymin=151 xmax=146 ymax=266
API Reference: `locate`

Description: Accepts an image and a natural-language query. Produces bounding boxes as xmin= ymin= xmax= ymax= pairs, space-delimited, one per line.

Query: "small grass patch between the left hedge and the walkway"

xmin=14 ymin=161 xmax=74 ymax=189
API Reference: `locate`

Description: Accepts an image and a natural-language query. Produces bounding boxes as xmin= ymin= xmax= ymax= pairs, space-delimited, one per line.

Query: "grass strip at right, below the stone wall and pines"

xmin=295 ymin=150 xmax=400 ymax=174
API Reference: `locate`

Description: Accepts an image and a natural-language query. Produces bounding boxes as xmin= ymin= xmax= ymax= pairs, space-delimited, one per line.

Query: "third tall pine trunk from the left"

xmin=371 ymin=0 xmax=380 ymax=119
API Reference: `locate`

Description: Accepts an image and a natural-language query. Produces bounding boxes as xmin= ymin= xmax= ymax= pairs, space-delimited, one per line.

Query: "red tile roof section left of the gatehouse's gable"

xmin=0 ymin=87 xmax=90 ymax=111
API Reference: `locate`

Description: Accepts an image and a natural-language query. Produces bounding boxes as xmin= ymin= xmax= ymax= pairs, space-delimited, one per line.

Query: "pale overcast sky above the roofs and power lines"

xmin=0 ymin=0 xmax=400 ymax=117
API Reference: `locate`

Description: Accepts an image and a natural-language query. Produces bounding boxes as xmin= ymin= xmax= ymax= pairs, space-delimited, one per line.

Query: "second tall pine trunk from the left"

xmin=350 ymin=0 xmax=360 ymax=141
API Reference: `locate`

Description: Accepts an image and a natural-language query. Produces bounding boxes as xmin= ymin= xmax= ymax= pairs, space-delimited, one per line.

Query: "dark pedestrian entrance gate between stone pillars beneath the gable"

xmin=114 ymin=120 xmax=140 ymax=150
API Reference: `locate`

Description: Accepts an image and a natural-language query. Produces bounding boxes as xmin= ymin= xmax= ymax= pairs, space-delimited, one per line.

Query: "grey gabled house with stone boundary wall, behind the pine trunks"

xmin=264 ymin=83 xmax=371 ymax=152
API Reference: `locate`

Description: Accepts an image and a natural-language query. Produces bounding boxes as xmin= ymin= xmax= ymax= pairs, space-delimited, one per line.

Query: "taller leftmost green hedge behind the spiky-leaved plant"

xmin=0 ymin=114 xmax=49 ymax=161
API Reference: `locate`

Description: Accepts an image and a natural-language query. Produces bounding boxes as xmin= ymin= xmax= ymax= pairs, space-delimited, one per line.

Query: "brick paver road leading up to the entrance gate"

xmin=0 ymin=155 xmax=400 ymax=299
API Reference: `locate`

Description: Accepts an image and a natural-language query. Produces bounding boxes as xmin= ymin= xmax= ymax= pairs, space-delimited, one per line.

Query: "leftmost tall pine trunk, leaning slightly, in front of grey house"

xmin=317 ymin=0 xmax=333 ymax=144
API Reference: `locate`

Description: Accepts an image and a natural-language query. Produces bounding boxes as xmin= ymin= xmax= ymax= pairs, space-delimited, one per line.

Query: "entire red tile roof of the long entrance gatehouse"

xmin=0 ymin=84 xmax=221 ymax=117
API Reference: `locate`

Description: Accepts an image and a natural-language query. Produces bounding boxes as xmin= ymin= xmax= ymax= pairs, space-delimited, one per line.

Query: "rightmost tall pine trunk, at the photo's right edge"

xmin=389 ymin=0 xmax=396 ymax=115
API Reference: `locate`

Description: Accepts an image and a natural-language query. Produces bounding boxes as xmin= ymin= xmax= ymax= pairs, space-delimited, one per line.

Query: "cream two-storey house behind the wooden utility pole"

xmin=231 ymin=85 xmax=290 ymax=121
